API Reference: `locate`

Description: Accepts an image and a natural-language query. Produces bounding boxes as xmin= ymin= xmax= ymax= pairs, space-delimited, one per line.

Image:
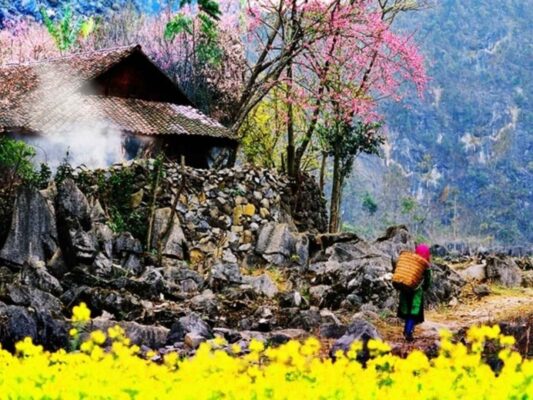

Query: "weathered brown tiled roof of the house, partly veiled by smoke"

xmin=0 ymin=46 xmax=233 ymax=139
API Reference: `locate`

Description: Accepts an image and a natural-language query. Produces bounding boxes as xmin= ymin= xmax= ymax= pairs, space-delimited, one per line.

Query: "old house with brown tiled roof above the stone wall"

xmin=0 ymin=46 xmax=238 ymax=168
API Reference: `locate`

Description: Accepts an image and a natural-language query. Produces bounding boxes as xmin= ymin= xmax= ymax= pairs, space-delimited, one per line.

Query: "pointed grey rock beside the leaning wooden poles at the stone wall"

xmin=152 ymin=207 xmax=185 ymax=260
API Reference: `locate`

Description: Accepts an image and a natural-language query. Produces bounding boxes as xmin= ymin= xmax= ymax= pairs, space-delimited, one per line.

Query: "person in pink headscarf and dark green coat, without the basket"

xmin=398 ymin=244 xmax=431 ymax=342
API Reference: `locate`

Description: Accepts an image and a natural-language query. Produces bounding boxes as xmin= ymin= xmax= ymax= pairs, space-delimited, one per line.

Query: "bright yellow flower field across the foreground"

xmin=0 ymin=307 xmax=533 ymax=400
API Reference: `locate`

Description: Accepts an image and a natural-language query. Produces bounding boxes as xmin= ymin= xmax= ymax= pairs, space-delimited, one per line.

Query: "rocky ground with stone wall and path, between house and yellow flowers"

xmin=0 ymin=165 xmax=533 ymax=355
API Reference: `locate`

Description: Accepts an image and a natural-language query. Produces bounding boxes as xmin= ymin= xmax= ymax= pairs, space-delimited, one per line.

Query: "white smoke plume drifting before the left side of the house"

xmin=23 ymin=64 xmax=125 ymax=171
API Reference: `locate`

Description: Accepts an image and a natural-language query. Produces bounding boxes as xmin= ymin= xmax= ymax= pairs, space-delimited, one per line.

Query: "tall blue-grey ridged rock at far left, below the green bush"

xmin=0 ymin=187 xmax=58 ymax=266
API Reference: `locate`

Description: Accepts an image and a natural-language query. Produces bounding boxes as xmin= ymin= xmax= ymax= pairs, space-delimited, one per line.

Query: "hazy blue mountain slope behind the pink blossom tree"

xmin=345 ymin=0 xmax=533 ymax=243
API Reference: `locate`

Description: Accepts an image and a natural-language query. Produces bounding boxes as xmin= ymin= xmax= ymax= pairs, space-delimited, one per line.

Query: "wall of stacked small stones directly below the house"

xmin=75 ymin=161 xmax=327 ymax=264
